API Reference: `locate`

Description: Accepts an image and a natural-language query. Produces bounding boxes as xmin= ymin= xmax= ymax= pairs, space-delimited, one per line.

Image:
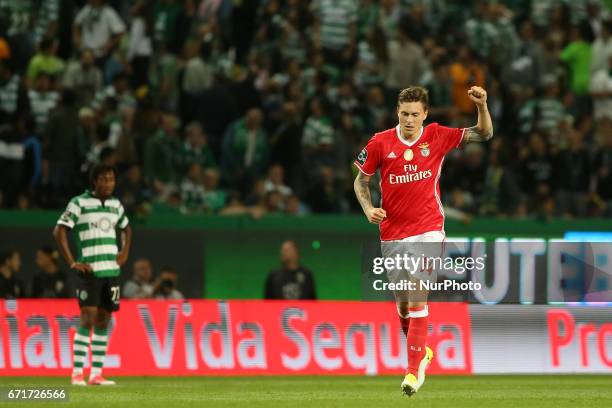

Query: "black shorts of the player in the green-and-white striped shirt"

xmin=76 ymin=272 xmax=120 ymax=312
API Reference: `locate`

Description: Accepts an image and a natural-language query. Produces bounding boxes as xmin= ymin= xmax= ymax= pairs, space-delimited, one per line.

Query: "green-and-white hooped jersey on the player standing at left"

xmin=57 ymin=190 xmax=128 ymax=278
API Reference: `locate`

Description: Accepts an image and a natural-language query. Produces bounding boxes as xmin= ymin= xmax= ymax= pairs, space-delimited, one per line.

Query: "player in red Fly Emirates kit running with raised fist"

xmin=354 ymin=86 xmax=493 ymax=396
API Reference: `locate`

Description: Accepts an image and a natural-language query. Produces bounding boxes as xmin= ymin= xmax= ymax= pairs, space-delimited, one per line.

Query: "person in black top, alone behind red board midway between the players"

xmin=264 ymin=240 xmax=317 ymax=300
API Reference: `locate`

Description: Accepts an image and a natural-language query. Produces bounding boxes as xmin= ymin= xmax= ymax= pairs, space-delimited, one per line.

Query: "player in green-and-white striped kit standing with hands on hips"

xmin=53 ymin=165 xmax=132 ymax=385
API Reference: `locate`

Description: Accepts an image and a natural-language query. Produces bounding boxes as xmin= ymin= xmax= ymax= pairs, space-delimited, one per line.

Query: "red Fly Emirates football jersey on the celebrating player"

xmin=355 ymin=123 xmax=464 ymax=241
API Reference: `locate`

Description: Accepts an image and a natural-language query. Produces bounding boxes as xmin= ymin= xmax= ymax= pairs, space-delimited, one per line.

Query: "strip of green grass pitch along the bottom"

xmin=0 ymin=375 xmax=612 ymax=408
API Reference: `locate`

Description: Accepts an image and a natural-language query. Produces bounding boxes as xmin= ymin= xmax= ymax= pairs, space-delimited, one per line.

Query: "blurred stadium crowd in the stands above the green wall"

xmin=0 ymin=0 xmax=612 ymax=220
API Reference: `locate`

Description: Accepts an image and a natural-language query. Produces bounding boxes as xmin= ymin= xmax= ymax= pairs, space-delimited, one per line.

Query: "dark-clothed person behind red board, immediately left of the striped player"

xmin=31 ymin=246 xmax=72 ymax=298
